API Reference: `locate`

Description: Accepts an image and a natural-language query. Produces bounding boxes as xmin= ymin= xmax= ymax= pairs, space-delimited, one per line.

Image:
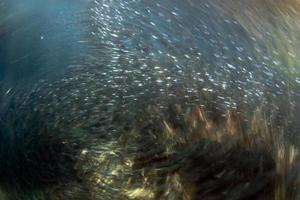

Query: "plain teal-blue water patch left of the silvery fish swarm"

xmin=0 ymin=0 xmax=86 ymax=88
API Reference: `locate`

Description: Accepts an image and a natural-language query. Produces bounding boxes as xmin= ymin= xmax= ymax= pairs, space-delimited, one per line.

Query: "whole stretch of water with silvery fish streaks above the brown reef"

xmin=0 ymin=0 xmax=300 ymax=199
